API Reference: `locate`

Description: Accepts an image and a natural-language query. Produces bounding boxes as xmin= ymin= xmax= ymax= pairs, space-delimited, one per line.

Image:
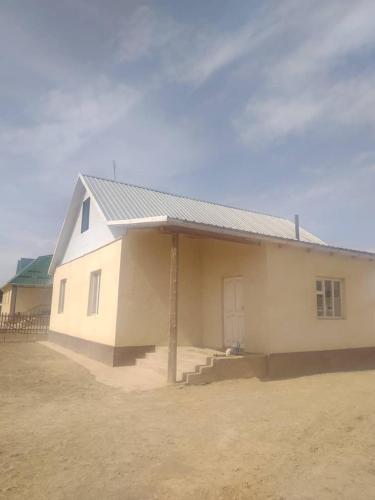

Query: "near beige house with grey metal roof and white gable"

xmin=50 ymin=175 xmax=375 ymax=378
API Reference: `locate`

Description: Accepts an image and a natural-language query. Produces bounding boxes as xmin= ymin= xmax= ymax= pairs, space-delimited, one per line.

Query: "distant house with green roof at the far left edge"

xmin=2 ymin=255 xmax=52 ymax=314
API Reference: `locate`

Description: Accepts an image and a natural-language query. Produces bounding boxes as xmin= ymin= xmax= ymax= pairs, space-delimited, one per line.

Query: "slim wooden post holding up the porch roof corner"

xmin=168 ymin=233 xmax=178 ymax=384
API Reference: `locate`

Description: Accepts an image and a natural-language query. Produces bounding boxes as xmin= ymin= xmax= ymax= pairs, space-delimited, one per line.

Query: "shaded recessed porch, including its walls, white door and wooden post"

xmin=116 ymin=229 xmax=266 ymax=381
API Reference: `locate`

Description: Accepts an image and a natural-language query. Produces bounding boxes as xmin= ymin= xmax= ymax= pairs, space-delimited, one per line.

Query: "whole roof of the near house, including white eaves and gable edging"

xmin=48 ymin=174 xmax=375 ymax=275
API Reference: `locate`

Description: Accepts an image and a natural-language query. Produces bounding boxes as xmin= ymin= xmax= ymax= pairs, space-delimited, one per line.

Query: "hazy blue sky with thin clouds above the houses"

xmin=0 ymin=0 xmax=375 ymax=284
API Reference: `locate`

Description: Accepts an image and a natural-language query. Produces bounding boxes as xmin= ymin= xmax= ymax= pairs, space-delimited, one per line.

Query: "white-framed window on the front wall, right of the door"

xmin=316 ymin=278 xmax=343 ymax=319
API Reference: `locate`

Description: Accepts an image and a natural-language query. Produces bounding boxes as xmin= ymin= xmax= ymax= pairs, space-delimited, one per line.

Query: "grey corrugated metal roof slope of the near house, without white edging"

xmin=82 ymin=175 xmax=325 ymax=245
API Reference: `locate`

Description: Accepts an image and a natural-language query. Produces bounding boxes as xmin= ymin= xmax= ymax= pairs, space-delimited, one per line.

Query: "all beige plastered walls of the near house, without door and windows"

xmin=51 ymin=230 xmax=375 ymax=353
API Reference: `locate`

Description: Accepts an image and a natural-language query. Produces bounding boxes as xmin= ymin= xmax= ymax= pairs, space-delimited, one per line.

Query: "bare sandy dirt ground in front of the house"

xmin=0 ymin=343 xmax=375 ymax=500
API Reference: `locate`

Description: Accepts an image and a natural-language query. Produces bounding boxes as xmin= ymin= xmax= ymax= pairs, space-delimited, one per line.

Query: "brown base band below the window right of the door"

xmin=268 ymin=347 xmax=375 ymax=379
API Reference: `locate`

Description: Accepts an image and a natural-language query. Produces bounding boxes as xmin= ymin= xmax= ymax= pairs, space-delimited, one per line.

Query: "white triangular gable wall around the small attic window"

xmin=61 ymin=190 xmax=123 ymax=264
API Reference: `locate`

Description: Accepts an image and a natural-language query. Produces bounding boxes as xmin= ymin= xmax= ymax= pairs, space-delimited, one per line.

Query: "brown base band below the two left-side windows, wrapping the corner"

xmin=48 ymin=331 xmax=155 ymax=366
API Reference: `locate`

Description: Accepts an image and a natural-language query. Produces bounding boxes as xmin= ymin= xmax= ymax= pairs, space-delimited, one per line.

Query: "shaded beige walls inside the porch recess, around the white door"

xmin=116 ymin=230 xmax=266 ymax=351
